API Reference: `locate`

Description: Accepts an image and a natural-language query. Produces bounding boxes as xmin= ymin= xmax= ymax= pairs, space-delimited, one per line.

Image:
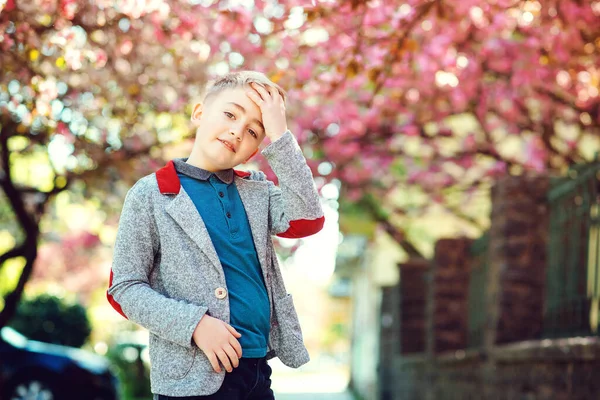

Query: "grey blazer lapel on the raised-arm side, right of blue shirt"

xmin=235 ymin=176 xmax=269 ymax=273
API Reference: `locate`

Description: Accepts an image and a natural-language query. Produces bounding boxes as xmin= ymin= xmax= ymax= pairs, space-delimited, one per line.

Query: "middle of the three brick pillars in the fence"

xmin=433 ymin=238 xmax=473 ymax=353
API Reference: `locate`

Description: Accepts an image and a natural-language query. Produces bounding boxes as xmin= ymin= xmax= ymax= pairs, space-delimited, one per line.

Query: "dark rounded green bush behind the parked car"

xmin=8 ymin=294 xmax=92 ymax=347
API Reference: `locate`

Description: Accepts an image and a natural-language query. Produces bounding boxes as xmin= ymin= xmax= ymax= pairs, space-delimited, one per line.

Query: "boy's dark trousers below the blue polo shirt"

xmin=158 ymin=357 xmax=275 ymax=400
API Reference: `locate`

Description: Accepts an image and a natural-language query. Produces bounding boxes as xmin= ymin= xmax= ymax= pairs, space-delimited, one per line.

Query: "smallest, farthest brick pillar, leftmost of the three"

xmin=399 ymin=259 xmax=431 ymax=354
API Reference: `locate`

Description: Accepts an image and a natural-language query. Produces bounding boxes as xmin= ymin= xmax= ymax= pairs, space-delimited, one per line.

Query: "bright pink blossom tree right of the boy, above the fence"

xmin=264 ymin=0 xmax=600 ymax=252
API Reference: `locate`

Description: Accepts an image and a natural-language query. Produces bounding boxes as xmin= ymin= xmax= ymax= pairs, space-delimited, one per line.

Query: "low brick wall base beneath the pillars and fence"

xmin=388 ymin=338 xmax=600 ymax=400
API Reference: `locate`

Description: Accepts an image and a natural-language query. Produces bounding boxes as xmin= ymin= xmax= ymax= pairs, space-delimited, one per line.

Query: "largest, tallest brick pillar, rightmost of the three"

xmin=484 ymin=176 xmax=549 ymax=349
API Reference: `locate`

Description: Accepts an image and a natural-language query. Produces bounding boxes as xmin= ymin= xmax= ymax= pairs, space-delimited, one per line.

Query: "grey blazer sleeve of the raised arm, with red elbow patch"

xmin=262 ymin=131 xmax=325 ymax=238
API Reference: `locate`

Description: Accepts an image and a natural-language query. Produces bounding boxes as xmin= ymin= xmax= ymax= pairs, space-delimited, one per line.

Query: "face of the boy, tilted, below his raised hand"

xmin=192 ymin=86 xmax=265 ymax=171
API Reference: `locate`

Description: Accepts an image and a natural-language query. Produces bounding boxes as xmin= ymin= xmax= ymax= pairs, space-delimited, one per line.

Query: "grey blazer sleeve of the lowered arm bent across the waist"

xmin=107 ymin=182 xmax=207 ymax=347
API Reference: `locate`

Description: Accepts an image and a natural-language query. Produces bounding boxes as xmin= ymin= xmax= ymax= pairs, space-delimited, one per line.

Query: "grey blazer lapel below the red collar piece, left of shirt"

xmin=165 ymin=187 xmax=224 ymax=275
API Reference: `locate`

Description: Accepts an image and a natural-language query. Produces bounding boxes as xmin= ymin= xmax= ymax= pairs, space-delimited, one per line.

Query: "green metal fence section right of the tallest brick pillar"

xmin=543 ymin=162 xmax=600 ymax=337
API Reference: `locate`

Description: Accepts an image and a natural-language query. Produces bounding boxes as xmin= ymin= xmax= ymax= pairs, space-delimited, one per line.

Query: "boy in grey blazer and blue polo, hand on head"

xmin=107 ymin=71 xmax=324 ymax=400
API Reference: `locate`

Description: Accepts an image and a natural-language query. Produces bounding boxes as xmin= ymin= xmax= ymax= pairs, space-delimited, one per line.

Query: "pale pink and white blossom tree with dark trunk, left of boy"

xmin=0 ymin=0 xmax=221 ymax=326
